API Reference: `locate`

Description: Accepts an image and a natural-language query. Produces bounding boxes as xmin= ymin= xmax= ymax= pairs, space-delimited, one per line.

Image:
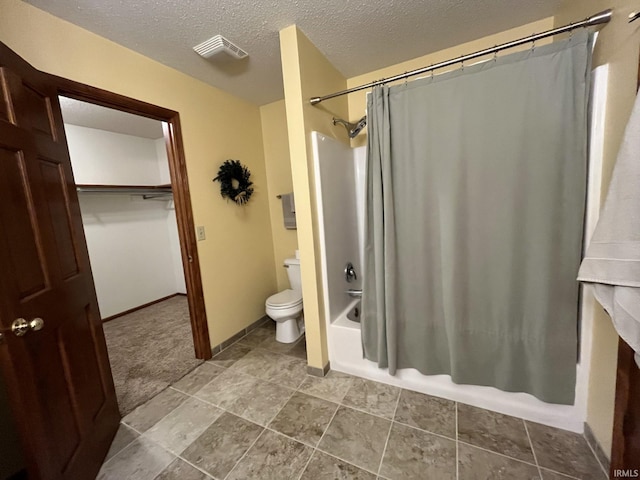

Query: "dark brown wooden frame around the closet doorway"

xmin=52 ymin=75 xmax=212 ymax=360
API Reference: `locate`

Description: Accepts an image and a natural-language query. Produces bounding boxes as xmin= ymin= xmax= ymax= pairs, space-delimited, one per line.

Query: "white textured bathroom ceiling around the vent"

xmin=27 ymin=0 xmax=561 ymax=105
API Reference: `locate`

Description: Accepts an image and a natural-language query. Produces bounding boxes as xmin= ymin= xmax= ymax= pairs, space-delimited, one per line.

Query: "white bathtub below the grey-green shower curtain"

xmin=327 ymin=299 xmax=584 ymax=432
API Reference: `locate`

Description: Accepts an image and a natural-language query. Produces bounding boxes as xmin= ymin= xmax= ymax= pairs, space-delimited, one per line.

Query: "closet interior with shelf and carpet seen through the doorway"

xmin=60 ymin=97 xmax=199 ymax=415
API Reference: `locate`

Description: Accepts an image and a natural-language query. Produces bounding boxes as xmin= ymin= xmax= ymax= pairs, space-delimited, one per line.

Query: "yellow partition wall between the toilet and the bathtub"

xmin=280 ymin=25 xmax=348 ymax=368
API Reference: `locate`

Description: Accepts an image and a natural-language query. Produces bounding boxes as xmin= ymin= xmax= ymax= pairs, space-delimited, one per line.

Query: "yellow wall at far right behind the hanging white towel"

xmin=555 ymin=0 xmax=640 ymax=455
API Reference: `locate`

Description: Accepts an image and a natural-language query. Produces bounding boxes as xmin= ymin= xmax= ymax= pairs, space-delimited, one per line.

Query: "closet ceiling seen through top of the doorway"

xmin=60 ymin=97 xmax=164 ymax=140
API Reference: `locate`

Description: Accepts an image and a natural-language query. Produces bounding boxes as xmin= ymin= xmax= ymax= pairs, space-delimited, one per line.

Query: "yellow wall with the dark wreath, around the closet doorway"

xmin=0 ymin=0 xmax=276 ymax=345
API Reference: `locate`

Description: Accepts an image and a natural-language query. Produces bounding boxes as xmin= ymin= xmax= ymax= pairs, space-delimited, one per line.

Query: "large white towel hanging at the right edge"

xmin=578 ymin=90 xmax=640 ymax=367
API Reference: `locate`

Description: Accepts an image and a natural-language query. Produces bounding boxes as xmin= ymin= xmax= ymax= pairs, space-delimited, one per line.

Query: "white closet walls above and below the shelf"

xmin=65 ymin=124 xmax=186 ymax=318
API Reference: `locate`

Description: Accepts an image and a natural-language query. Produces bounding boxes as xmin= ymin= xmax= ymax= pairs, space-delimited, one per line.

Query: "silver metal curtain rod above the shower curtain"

xmin=309 ymin=8 xmax=612 ymax=105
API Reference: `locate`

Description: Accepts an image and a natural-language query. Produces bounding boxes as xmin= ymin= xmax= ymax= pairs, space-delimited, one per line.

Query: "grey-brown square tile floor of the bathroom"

xmin=98 ymin=323 xmax=607 ymax=480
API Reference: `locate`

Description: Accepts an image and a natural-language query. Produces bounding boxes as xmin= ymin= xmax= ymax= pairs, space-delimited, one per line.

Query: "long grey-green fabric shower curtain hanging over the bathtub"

xmin=362 ymin=32 xmax=591 ymax=404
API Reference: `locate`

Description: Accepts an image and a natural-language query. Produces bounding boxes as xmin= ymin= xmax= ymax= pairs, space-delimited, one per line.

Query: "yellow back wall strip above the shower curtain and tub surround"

xmin=348 ymin=17 xmax=553 ymax=147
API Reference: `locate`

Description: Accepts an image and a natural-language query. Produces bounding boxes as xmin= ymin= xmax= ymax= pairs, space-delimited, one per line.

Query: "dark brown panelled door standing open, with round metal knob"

xmin=0 ymin=44 xmax=119 ymax=480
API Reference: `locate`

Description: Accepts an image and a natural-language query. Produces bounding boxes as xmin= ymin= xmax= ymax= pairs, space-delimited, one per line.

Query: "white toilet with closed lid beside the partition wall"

xmin=265 ymin=258 xmax=304 ymax=343
